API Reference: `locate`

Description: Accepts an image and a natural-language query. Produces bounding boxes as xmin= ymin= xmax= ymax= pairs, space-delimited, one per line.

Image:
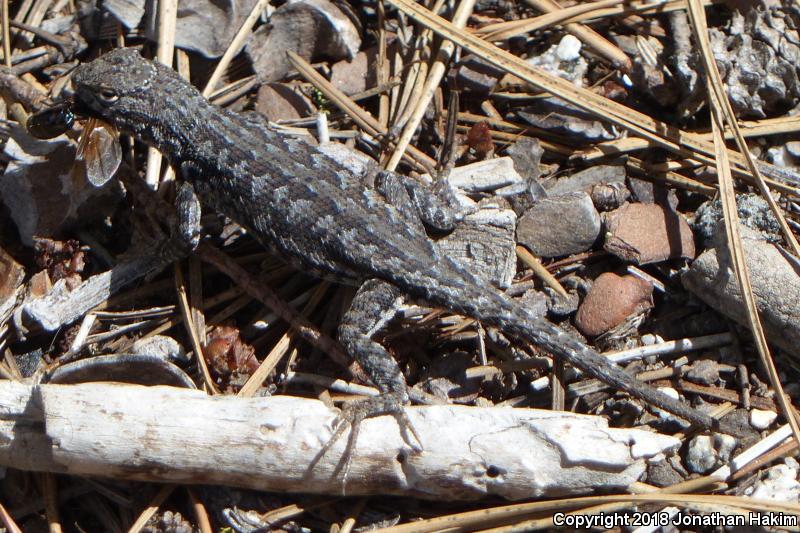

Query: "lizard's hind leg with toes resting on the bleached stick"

xmin=325 ymin=279 xmax=422 ymax=461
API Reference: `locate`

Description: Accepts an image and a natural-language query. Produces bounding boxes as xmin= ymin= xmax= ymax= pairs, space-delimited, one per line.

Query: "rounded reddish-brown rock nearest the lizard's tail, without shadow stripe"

xmin=575 ymin=272 xmax=653 ymax=337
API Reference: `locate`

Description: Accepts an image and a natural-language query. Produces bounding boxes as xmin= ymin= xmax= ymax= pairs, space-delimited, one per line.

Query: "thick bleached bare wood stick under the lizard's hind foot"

xmin=0 ymin=381 xmax=680 ymax=500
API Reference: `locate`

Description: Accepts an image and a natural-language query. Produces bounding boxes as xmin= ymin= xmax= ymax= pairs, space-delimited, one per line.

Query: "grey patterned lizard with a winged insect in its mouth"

xmin=64 ymin=48 xmax=734 ymax=444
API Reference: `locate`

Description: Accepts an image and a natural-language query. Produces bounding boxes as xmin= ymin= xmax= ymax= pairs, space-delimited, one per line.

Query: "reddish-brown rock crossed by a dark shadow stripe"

xmin=604 ymin=204 xmax=695 ymax=265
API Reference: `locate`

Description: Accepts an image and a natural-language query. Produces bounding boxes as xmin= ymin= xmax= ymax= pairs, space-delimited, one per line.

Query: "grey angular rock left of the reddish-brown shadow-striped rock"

xmin=517 ymin=192 xmax=600 ymax=257
